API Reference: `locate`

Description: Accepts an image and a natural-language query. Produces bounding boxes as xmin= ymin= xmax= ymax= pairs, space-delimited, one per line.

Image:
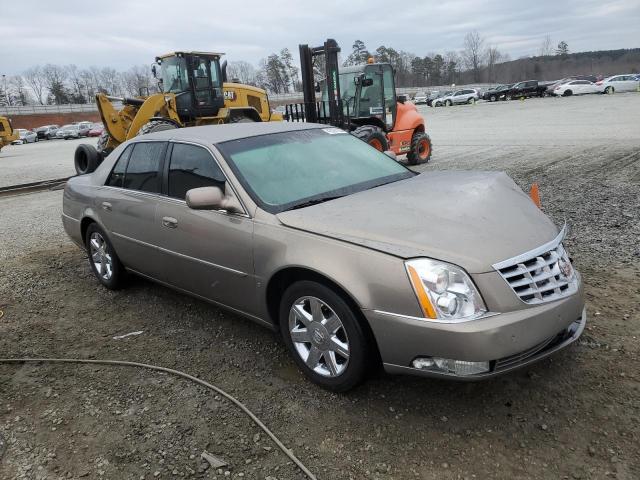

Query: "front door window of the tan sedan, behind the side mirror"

xmin=168 ymin=143 xmax=225 ymax=200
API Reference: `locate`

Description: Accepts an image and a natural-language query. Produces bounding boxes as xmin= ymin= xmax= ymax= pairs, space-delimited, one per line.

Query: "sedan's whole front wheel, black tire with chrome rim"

xmin=279 ymin=281 xmax=371 ymax=392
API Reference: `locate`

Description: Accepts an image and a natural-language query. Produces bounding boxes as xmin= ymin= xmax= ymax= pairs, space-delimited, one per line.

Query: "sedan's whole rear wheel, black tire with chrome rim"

xmin=84 ymin=223 xmax=126 ymax=290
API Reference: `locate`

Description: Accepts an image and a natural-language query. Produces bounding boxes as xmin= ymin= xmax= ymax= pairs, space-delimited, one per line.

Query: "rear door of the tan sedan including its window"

xmin=95 ymin=142 xmax=167 ymax=278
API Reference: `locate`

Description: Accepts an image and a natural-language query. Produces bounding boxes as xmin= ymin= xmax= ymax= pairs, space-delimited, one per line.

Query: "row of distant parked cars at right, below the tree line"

xmin=413 ymin=74 xmax=640 ymax=107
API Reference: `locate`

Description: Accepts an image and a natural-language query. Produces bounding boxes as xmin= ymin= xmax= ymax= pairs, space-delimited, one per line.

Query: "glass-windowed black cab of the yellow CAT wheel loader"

xmin=153 ymin=52 xmax=224 ymax=121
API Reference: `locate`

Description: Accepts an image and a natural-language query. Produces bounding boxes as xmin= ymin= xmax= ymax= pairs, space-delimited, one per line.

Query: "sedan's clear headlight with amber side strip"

xmin=405 ymin=258 xmax=487 ymax=320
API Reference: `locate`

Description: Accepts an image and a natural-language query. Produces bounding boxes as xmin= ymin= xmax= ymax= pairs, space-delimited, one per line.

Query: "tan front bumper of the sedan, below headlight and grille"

xmin=364 ymin=287 xmax=586 ymax=380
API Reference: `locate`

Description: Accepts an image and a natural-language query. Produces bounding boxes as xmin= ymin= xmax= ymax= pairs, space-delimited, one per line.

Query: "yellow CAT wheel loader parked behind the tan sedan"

xmin=74 ymin=52 xmax=282 ymax=175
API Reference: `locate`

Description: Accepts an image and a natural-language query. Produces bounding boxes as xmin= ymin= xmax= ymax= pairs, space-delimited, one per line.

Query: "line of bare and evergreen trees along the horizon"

xmin=0 ymin=31 xmax=640 ymax=105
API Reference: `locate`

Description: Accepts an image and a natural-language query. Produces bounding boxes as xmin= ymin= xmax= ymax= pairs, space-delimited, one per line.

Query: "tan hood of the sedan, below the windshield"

xmin=277 ymin=171 xmax=559 ymax=273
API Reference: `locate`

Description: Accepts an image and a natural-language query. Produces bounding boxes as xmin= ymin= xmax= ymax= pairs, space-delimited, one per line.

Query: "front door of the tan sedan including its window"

xmin=155 ymin=142 xmax=255 ymax=313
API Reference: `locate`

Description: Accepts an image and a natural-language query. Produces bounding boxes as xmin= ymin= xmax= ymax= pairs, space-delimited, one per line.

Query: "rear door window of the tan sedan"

xmin=124 ymin=142 xmax=167 ymax=193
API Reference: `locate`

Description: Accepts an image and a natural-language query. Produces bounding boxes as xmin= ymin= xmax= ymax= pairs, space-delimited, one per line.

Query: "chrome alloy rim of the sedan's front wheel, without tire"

xmin=289 ymin=297 xmax=349 ymax=377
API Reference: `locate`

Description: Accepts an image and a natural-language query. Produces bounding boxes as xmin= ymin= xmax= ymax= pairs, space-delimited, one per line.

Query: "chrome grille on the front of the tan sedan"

xmin=493 ymin=228 xmax=578 ymax=304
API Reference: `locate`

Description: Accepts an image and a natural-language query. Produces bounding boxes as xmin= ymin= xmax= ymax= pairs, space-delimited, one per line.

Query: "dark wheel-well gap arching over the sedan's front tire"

xmin=265 ymin=266 xmax=381 ymax=362
